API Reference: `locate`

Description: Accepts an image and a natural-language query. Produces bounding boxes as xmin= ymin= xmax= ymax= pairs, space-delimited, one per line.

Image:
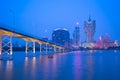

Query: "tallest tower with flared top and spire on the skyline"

xmin=84 ymin=16 xmax=96 ymax=43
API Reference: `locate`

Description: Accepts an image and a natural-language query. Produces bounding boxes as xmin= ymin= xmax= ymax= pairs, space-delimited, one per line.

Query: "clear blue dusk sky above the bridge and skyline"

xmin=0 ymin=0 xmax=120 ymax=41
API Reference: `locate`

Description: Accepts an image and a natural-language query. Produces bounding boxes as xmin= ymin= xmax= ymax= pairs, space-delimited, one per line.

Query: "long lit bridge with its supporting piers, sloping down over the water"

xmin=0 ymin=26 xmax=64 ymax=59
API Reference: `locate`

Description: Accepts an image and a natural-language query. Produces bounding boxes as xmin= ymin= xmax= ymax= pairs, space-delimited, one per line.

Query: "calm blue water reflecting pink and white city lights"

xmin=0 ymin=50 xmax=120 ymax=80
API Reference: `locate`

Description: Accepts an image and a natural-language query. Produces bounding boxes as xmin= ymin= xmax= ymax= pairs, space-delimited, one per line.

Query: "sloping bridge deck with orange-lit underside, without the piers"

xmin=0 ymin=26 xmax=63 ymax=48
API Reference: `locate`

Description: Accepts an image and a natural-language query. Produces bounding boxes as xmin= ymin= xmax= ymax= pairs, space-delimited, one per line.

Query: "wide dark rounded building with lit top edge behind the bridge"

xmin=52 ymin=28 xmax=70 ymax=46
